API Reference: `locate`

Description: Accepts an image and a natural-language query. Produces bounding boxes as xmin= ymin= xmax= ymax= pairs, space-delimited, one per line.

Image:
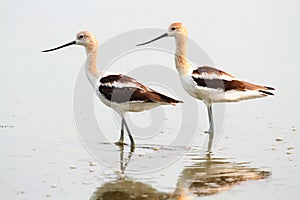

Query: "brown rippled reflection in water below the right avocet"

xmin=174 ymin=154 xmax=271 ymax=199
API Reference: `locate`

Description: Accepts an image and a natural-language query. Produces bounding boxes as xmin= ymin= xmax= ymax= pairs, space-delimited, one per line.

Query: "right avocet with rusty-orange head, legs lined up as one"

xmin=137 ymin=22 xmax=274 ymax=138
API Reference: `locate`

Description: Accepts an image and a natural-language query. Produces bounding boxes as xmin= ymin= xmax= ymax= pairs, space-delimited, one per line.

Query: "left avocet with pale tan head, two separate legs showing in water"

xmin=42 ymin=31 xmax=182 ymax=146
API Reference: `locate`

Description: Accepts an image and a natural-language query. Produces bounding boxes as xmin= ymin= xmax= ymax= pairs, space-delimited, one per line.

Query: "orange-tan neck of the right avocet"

xmin=175 ymin=35 xmax=191 ymax=74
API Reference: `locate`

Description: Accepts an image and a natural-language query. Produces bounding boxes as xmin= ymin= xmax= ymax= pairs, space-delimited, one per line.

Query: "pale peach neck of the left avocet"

xmin=85 ymin=45 xmax=101 ymax=86
